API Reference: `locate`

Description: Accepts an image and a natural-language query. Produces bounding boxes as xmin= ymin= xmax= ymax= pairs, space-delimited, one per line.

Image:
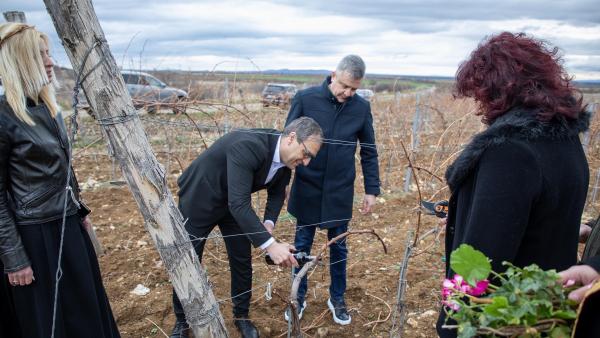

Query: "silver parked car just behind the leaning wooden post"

xmin=78 ymin=70 xmax=188 ymax=115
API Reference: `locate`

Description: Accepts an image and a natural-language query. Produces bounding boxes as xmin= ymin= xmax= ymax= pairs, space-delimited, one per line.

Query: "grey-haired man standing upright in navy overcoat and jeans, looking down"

xmin=286 ymin=55 xmax=380 ymax=325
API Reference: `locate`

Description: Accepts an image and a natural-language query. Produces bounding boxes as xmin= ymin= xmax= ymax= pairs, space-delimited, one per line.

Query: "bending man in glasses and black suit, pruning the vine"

xmin=171 ymin=117 xmax=323 ymax=337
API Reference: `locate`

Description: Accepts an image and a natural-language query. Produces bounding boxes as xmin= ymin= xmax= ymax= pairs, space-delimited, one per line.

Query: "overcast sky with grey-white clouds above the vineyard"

xmin=0 ymin=0 xmax=600 ymax=80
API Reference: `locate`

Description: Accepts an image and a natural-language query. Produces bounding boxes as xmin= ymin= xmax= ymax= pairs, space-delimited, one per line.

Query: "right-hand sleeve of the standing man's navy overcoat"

xmin=358 ymin=105 xmax=381 ymax=196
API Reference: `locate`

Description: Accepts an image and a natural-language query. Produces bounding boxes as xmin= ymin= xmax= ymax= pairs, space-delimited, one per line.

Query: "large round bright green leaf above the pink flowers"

xmin=450 ymin=244 xmax=492 ymax=286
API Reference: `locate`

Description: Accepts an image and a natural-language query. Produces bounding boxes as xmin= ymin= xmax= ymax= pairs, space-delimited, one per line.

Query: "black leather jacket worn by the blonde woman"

xmin=0 ymin=96 xmax=79 ymax=273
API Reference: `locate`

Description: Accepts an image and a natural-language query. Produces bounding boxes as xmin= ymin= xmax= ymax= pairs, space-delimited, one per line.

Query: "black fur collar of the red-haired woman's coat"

xmin=446 ymin=108 xmax=590 ymax=192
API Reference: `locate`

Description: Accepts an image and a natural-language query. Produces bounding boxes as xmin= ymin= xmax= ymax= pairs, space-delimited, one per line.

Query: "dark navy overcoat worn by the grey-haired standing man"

xmin=286 ymin=77 xmax=380 ymax=228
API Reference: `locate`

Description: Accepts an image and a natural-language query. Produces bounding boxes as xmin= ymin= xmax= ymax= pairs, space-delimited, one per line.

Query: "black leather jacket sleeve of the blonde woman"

xmin=0 ymin=126 xmax=31 ymax=273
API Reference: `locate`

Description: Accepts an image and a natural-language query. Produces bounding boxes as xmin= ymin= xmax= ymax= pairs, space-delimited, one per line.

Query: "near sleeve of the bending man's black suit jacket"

xmin=227 ymin=142 xmax=271 ymax=247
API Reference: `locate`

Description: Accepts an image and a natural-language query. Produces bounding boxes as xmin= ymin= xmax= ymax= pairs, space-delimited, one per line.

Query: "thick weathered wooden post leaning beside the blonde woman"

xmin=44 ymin=0 xmax=227 ymax=337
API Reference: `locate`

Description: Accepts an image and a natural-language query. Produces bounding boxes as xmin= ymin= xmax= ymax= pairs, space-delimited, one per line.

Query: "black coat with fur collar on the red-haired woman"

xmin=438 ymin=109 xmax=589 ymax=337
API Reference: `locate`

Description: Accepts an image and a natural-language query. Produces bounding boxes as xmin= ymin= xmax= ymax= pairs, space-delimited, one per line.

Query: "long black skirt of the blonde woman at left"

xmin=9 ymin=215 xmax=120 ymax=338
